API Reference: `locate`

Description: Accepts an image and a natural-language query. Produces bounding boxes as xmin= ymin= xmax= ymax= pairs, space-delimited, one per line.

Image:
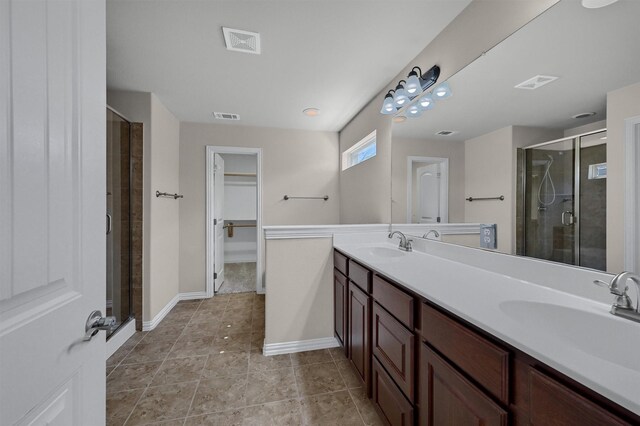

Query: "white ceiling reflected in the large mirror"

xmin=393 ymin=0 xmax=640 ymax=141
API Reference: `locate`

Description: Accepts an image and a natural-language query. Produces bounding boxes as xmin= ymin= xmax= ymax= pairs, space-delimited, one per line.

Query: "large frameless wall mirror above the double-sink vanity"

xmin=392 ymin=0 xmax=640 ymax=272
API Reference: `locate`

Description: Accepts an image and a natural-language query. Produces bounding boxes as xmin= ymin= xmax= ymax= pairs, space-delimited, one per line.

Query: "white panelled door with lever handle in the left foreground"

xmin=0 ymin=0 xmax=106 ymax=426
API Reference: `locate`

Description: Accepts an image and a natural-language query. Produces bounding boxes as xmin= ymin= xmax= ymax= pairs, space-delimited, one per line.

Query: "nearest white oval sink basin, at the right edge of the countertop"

xmin=500 ymin=300 xmax=640 ymax=371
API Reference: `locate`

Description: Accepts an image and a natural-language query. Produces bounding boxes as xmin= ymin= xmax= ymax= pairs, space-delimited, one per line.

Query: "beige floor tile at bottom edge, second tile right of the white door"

xmin=127 ymin=382 xmax=198 ymax=425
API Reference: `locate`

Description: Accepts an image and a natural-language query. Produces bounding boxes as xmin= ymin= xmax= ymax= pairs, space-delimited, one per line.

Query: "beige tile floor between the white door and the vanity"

xmin=107 ymin=293 xmax=382 ymax=426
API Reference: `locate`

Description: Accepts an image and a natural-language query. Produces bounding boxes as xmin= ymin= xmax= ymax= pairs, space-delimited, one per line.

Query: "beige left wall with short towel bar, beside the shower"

xmin=107 ymin=90 xmax=180 ymax=322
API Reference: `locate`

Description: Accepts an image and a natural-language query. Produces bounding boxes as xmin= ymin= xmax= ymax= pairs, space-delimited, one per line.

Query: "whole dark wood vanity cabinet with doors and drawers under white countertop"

xmin=334 ymin=252 xmax=640 ymax=426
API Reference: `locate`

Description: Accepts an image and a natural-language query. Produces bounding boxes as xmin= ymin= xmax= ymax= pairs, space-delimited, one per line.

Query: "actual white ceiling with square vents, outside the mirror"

xmin=107 ymin=0 xmax=470 ymax=131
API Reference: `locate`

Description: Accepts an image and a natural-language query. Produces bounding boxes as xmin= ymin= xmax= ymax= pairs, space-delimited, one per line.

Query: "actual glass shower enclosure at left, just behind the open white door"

xmin=105 ymin=107 xmax=132 ymax=338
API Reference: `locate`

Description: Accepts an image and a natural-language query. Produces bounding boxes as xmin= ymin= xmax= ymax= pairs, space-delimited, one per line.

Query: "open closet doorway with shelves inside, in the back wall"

xmin=206 ymin=146 xmax=264 ymax=297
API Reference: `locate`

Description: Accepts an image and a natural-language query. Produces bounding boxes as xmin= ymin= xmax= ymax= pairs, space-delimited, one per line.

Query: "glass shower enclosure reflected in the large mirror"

xmin=516 ymin=131 xmax=607 ymax=270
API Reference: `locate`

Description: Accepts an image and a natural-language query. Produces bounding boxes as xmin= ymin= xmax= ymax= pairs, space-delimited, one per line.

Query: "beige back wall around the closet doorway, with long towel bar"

xmin=180 ymin=123 xmax=339 ymax=293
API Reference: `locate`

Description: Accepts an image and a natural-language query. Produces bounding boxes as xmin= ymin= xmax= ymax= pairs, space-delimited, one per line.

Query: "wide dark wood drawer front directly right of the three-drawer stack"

xmin=421 ymin=304 xmax=509 ymax=404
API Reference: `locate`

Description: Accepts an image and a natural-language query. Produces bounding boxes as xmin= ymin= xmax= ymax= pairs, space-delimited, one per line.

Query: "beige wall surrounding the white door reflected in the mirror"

xmin=391 ymin=138 xmax=465 ymax=223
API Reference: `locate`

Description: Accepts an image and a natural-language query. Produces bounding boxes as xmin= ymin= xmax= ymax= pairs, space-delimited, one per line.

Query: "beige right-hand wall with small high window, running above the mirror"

xmin=340 ymin=0 xmax=558 ymax=223
